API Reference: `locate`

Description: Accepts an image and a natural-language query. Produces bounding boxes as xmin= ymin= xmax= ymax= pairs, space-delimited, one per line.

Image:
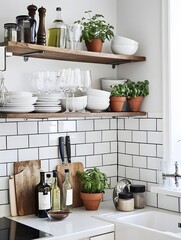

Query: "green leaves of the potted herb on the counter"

xmin=77 ymin=168 xmax=110 ymax=193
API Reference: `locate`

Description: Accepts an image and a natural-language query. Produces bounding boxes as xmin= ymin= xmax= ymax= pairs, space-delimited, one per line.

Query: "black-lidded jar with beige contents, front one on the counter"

xmin=117 ymin=192 xmax=134 ymax=212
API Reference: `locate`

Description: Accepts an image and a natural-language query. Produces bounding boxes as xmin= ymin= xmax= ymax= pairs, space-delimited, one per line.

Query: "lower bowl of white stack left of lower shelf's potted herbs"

xmin=86 ymin=96 xmax=109 ymax=112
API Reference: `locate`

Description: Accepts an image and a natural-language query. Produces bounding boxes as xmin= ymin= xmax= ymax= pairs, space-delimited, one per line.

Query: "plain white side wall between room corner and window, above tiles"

xmin=117 ymin=0 xmax=162 ymax=112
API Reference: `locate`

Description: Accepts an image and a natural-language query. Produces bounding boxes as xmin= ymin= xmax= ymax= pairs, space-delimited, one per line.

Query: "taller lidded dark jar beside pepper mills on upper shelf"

xmin=16 ymin=15 xmax=31 ymax=43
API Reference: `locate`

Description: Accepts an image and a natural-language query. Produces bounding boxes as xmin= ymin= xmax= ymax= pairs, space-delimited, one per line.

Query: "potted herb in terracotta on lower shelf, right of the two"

xmin=125 ymin=80 xmax=149 ymax=112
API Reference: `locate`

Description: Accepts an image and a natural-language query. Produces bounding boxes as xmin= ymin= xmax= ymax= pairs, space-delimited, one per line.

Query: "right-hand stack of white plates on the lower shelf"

xmin=35 ymin=94 xmax=62 ymax=113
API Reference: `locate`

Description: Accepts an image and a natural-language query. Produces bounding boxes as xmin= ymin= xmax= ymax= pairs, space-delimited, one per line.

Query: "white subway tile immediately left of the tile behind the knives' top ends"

xmin=29 ymin=134 xmax=48 ymax=147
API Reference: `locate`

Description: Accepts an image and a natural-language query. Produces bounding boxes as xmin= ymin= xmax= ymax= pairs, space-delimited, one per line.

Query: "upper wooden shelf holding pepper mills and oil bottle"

xmin=0 ymin=42 xmax=146 ymax=66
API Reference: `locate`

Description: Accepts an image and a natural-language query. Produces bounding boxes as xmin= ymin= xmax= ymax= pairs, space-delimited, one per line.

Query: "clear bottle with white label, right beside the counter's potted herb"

xmin=62 ymin=169 xmax=73 ymax=210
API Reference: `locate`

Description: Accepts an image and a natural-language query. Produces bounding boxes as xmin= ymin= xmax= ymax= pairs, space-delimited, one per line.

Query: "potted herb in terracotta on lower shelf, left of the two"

xmin=110 ymin=83 xmax=127 ymax=112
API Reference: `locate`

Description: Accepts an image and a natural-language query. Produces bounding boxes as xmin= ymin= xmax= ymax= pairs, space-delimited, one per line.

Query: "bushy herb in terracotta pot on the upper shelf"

xmin=75 ymin=11 xmax=114 ymax=52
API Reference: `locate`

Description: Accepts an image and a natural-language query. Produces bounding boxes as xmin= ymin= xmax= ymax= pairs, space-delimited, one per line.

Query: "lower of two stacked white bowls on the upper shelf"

xmin=111 ymin=44 xmax=138 ymax=55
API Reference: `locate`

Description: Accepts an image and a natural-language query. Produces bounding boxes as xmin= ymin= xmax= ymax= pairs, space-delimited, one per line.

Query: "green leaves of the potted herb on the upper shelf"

xmin=75 ymin=11 xmax=114 ymax=42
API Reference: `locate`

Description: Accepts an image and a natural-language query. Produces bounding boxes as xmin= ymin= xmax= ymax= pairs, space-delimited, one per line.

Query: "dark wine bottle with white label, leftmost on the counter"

xmin=35 ymin=172 xmax=51 ymax=218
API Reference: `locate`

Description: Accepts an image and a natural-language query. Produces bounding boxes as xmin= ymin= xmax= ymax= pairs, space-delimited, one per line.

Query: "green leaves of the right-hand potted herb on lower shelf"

xmin=125 ymin=79 xmax=149 ymax=98
